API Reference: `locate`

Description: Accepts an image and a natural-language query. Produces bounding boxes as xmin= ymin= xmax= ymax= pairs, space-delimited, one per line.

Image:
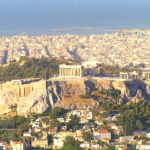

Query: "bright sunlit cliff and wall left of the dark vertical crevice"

xmin=0 ymin=80 xmax=49 ymax=115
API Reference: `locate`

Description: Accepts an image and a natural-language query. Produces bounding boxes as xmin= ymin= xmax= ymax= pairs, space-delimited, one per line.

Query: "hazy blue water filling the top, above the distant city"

xmin=0 ymin=0 xmax=150 ymax=36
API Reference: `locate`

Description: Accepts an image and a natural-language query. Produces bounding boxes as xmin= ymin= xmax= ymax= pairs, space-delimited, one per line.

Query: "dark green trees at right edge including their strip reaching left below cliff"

xmin=101 ymin=100 xmax=150 ymax=135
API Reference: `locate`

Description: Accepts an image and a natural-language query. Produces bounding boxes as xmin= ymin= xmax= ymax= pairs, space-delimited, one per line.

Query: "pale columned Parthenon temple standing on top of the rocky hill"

xmin=59 ymin=64 xmax=84 ymax=77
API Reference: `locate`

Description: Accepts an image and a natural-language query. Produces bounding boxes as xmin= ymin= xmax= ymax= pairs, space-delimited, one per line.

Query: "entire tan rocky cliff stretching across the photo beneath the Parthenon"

xmin=0 ymin=78 xmax=150 ymax=115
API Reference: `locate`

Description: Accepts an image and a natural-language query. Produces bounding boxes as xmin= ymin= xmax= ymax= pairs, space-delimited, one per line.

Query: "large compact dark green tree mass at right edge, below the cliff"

xmin=118 ymin=101 xmax=150 ymax=135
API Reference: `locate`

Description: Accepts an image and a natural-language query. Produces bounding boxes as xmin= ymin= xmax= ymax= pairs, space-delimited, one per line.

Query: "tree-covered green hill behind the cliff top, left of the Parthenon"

xmin=0 ymin=58 xmax=71 ymax=82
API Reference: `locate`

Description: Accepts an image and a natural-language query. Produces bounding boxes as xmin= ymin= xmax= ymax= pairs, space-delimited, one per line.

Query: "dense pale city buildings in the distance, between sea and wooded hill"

xmin=0 ymin=30 xmax=150 ymax=67
